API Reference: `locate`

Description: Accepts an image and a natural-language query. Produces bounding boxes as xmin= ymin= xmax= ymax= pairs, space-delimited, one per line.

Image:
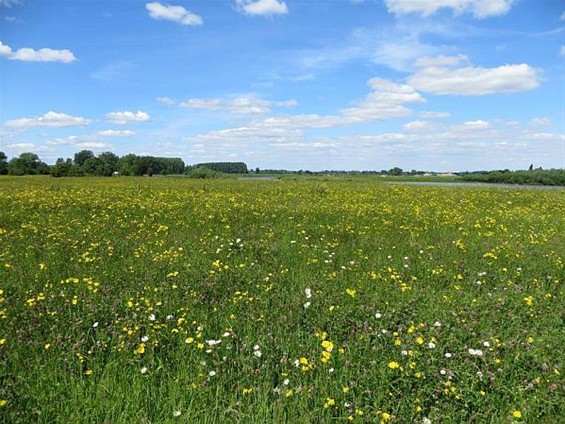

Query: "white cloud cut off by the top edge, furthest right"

xmin=385 ymin=0 xmax=516 ymax=19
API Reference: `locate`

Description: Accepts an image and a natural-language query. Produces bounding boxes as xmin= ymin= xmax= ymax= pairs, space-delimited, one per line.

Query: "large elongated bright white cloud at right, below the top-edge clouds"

xmin=408 ymin=63 xmax=540 ymax=96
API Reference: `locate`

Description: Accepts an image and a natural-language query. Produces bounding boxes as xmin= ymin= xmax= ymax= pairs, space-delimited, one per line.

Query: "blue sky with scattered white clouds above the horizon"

xmin=0 ymin=0 xmax=565 ymax=171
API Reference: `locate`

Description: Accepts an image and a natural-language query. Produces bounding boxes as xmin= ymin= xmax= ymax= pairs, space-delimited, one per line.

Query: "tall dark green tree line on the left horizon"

xmin=0 ymin=150 xmax=247 ymax=177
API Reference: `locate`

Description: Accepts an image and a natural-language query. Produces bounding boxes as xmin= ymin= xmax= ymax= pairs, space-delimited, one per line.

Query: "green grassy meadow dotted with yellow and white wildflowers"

xmin=0 ymin=177 xmax=565 ymax=423
